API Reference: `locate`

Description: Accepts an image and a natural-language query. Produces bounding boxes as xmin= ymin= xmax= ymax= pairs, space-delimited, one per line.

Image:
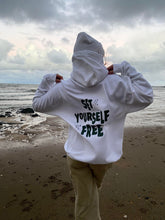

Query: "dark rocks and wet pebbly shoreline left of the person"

xmin=0 ymin=108 xmax=46 ymax=142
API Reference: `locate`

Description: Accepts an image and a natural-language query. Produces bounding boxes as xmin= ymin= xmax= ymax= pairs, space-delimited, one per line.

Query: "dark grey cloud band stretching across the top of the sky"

xmin=0 ymin=0 xmax=165 ymax=31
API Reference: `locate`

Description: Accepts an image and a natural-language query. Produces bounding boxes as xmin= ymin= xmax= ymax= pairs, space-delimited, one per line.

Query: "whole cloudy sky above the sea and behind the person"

xmin=0 ymin=0 xmax=165 ymax=85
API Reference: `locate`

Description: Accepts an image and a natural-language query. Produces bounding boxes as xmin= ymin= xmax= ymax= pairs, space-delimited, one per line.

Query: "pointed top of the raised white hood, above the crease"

xmin=74 ymin=32 xmax=104 ymax=56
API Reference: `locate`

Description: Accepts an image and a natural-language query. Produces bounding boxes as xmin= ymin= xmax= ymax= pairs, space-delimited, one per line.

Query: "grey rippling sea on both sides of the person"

xmin=0 ymin=83 xmax=165 ymax=127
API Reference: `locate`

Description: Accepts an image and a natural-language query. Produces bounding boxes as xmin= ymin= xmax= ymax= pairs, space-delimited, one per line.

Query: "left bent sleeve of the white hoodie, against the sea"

xmin=32 ymin=74 xmax=62 ymax=113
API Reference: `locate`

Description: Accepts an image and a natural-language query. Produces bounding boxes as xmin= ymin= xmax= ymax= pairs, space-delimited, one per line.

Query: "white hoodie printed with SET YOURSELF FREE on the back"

xmin=33 ymin=33 xmax=153 ymax=164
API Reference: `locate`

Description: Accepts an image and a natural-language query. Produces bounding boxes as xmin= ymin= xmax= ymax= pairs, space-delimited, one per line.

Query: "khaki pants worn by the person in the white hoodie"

xmin=68 ymin=157 xmax=111 ymax=220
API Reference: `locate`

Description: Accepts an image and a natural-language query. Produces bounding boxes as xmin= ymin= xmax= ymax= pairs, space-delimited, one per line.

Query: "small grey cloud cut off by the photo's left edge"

xmin=0 ymin=39 xmax=14 ymax=61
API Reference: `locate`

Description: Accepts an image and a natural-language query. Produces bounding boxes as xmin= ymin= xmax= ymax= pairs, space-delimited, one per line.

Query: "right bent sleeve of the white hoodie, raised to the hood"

xmin=113 ymin=61 xmax=153 ymax=113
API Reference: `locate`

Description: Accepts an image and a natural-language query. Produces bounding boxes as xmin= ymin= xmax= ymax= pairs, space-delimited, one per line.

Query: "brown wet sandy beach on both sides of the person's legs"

xmin=0 ymin=117 xmax=165 ymax=220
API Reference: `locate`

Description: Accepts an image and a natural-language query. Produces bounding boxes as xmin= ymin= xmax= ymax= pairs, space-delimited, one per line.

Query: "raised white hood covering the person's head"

xmin=71 ymin=32 xmax=108 ymax=87
